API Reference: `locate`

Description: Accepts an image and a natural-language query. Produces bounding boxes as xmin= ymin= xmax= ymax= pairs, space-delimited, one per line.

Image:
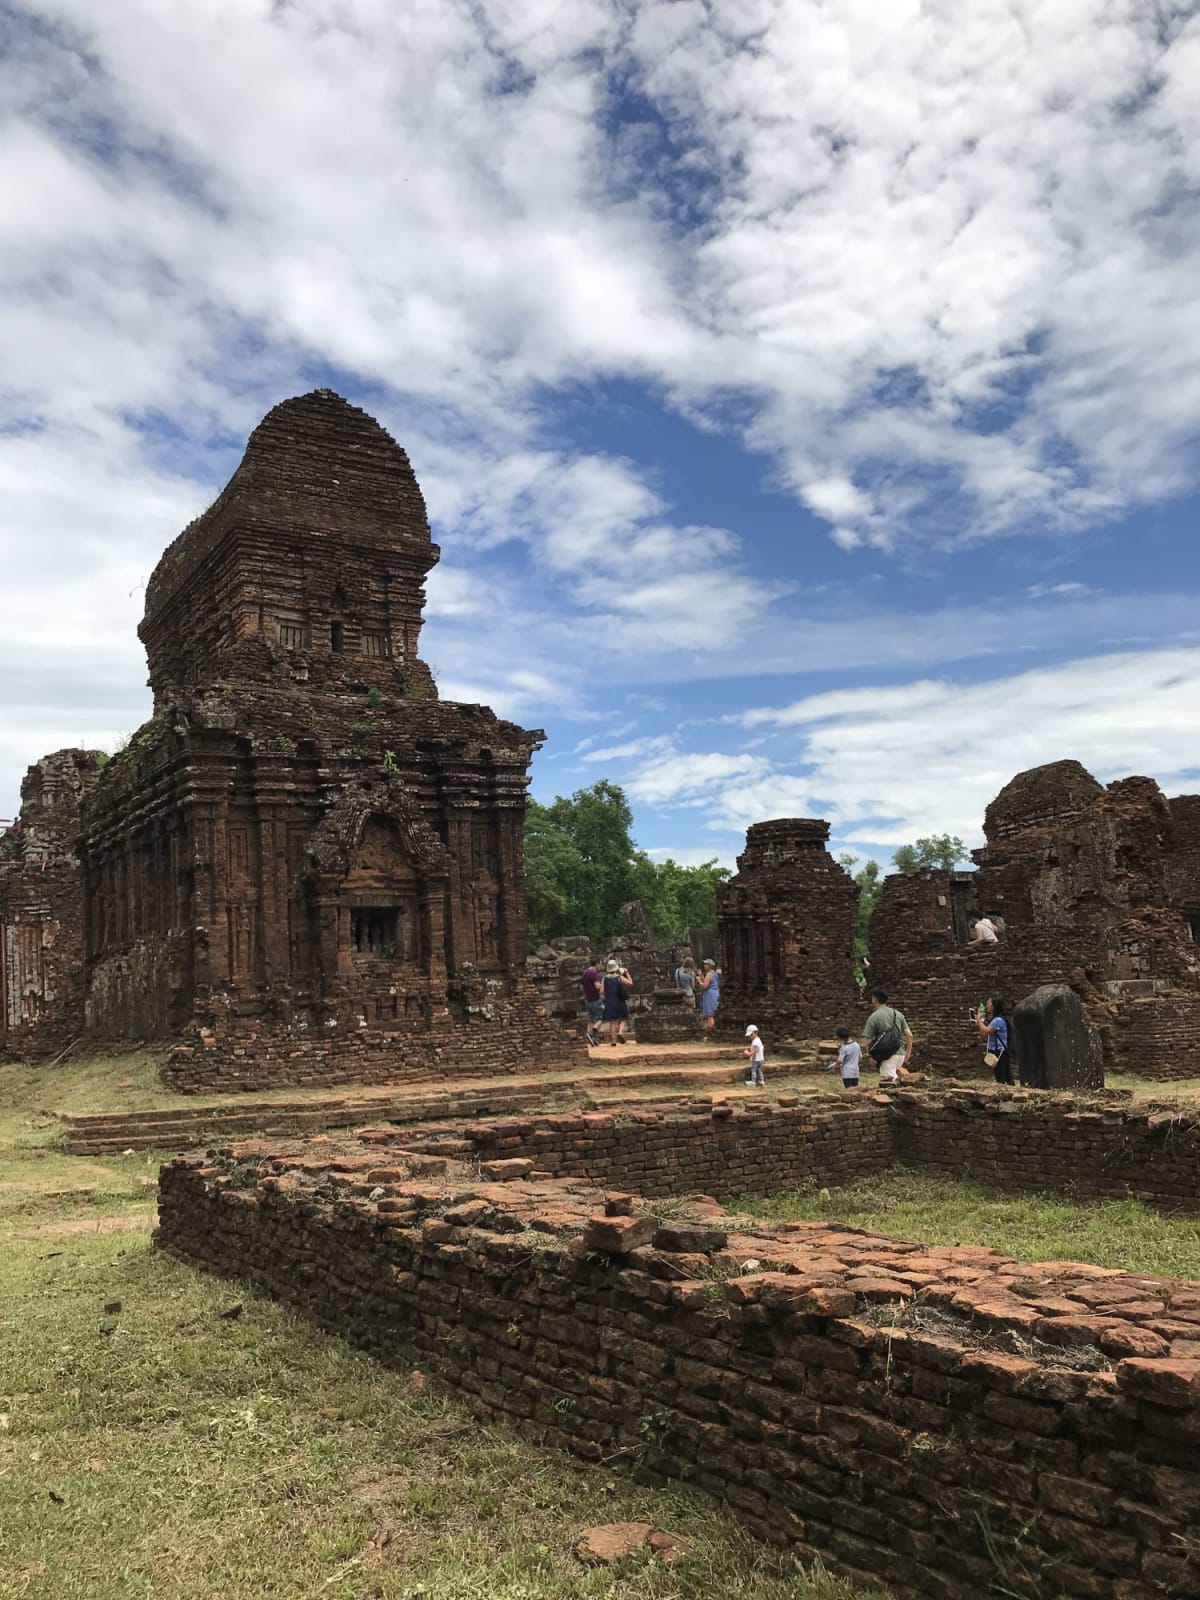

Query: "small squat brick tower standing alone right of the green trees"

xmin=717 ymin=818 xmax=859 ymax=1042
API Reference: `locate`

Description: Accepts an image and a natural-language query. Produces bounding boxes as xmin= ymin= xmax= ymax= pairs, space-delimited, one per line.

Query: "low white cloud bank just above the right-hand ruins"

xmin=613 ymin=650 xmax=1200 ymax=846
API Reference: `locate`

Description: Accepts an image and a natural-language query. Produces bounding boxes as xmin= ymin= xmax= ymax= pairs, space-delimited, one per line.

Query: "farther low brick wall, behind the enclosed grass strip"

xmin=397 ymin=1088 xmax=1200 ymax=1208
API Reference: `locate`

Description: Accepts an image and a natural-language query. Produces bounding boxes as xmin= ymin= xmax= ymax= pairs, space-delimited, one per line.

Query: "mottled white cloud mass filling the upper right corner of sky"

xmin=634 ymin=0 xmax=1200 ymax=547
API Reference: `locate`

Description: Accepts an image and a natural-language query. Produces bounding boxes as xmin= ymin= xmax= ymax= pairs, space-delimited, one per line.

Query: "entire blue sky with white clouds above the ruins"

xmin=0 ymin=0 xmax=1200 ymax=862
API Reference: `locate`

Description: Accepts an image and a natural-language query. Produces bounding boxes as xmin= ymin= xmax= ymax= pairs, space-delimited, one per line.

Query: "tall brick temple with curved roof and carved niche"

xmin=57 ymin=390 xmax=573 ymax=1090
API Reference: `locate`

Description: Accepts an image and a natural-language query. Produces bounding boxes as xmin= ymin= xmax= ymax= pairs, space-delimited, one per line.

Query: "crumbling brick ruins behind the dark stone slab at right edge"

xmin=870 ymin=762 xmax=1200 ymax=1077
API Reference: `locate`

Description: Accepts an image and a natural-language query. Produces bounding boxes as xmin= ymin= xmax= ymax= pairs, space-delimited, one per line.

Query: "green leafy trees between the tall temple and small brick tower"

xmin=525 ymin=779 xmax=728 ymax=946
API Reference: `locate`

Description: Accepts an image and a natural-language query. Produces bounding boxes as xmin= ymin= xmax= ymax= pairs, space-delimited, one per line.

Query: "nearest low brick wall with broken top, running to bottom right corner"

xmin=160 ymin=1132 xmax=1200 ymax=1600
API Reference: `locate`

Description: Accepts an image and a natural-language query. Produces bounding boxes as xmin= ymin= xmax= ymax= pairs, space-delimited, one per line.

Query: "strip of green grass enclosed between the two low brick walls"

xmin=731 ymin=1166 xmax=1200 ymax=1278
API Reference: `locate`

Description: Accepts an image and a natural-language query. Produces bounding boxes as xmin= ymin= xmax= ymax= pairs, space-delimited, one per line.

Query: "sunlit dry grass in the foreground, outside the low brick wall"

xmin=0 ymin=1078 xmax=886 ymax=1600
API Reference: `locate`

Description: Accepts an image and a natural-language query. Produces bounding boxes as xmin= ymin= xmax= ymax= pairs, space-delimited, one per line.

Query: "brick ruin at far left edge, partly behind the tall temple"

xmin=0 ymin=750 xmax=104 ymax=1061
